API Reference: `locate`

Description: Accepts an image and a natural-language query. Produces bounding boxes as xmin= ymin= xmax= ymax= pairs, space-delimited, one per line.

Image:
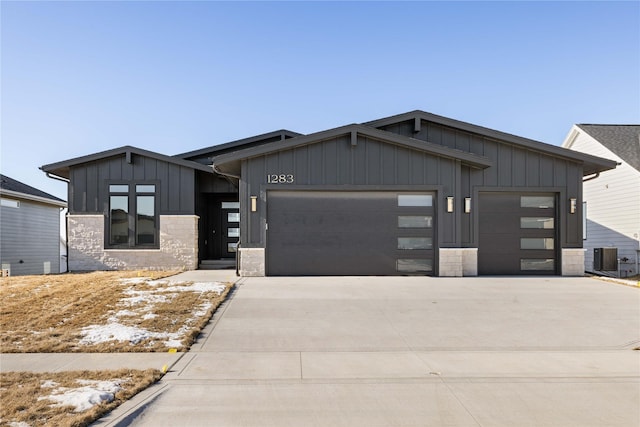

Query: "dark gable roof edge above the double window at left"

xmin=40 ymin=145 xmax=213 ymax=179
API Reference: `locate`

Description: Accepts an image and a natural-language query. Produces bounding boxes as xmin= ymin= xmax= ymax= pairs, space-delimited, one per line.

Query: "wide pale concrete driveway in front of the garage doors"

xmin=96 ymin=277 xmax=640 ymax=427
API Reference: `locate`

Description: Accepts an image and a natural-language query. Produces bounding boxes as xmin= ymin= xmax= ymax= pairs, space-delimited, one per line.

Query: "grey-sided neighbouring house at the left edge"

xmin=0 ymin=175 xmax=67 ymax=276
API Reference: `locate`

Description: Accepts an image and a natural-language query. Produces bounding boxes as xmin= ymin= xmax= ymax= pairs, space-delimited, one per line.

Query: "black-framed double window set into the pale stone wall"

xmin=106 ymin=183 xmax=158 ymax=248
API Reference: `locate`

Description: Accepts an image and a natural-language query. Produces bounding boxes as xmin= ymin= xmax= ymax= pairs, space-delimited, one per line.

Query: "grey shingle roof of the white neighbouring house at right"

xmin=577 ymin=124 xmax=640 ymax=171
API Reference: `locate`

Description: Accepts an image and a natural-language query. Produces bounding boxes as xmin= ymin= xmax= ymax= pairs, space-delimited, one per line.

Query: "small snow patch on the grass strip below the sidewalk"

xmin=38 ymin=380 xmax=122 ymax=412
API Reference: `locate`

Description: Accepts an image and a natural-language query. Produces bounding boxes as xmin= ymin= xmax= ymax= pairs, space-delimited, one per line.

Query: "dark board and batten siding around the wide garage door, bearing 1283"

xmin=240 ymin=135 xmax=460 ymax=247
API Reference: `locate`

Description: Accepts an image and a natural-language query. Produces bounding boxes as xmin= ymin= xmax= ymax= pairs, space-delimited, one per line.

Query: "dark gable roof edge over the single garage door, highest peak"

xmin=364 ymin=110 xmax=616 ymax=176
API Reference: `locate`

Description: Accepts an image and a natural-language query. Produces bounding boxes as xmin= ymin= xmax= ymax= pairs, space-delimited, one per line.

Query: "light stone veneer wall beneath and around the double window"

xmin=67 ymin=215 xmax=199 ymax=271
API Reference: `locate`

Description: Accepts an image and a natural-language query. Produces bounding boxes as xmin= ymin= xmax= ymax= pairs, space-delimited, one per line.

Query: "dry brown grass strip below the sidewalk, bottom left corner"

xmin=0 ymin=369 xmax=162 ymax=427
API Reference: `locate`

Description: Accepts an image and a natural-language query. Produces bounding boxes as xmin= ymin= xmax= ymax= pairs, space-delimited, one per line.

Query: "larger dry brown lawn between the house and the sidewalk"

xmin=0 ymin=271 xmax=231 ymax=353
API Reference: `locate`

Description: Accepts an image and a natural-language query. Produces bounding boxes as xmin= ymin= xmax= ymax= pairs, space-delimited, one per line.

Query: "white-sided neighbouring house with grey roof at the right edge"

xmin=562 ymin=124 xmax=640 ymax=277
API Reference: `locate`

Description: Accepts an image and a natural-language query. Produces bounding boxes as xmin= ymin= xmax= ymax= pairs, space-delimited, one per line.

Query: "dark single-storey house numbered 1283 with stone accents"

xmin=41 ymin=111 xmax=616 ymax=276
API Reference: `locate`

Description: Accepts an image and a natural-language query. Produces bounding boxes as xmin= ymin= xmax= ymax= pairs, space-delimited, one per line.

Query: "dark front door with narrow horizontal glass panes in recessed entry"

xmin=206 ymin=194 xmax=240 ymax=259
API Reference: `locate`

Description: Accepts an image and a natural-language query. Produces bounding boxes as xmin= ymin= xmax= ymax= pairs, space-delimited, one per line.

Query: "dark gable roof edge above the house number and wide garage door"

xmin=213 ymin=124 xmax=493 ymax=173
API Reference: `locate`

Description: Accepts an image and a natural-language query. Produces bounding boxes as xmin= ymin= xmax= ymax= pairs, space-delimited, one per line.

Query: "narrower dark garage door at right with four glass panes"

xmin=478 ymin=193 xmax=558 ymax=275
